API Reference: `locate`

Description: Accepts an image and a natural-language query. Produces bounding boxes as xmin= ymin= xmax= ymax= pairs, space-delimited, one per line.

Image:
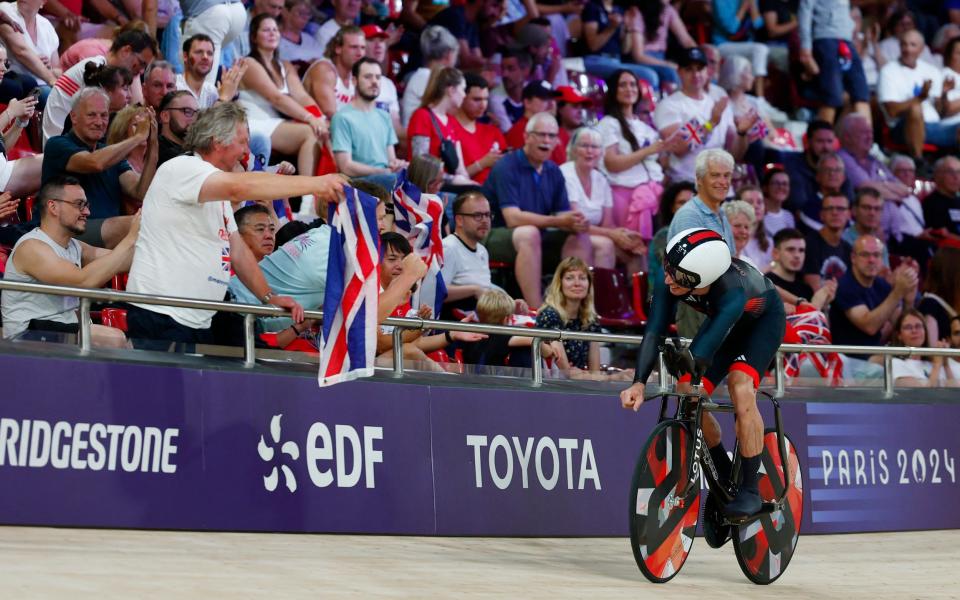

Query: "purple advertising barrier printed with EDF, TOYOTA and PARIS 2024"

xmin=0 ymin=355 xmax=960 ymax=536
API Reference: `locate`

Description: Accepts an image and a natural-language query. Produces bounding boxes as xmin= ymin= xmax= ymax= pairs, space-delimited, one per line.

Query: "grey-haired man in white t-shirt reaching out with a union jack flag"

xmin=127 ymin=102 xmax=344 ymax=349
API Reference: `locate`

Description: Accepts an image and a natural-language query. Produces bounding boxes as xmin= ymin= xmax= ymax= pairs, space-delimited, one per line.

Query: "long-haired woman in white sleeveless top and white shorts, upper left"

xmin=240 ymin=15 xmax=328 ymax=183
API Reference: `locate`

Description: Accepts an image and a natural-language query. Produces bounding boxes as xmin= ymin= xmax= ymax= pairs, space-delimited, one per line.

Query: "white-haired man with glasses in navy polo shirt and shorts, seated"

xmin=483 ymin=113 xmax=590 ymax=307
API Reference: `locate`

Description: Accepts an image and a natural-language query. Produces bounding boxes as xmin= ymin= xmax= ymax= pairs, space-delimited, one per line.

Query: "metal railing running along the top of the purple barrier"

xmin=0 ymin=279 xmax=960 ymax=398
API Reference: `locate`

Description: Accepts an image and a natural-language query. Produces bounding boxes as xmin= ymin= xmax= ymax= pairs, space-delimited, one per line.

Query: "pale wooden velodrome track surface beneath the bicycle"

xmin=0 ymin=527 xmax=960 ymax=600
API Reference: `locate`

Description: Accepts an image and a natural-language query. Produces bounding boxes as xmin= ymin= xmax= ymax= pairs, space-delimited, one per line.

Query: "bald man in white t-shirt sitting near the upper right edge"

xmin=877 ymin=29 xmax=960 ymax=158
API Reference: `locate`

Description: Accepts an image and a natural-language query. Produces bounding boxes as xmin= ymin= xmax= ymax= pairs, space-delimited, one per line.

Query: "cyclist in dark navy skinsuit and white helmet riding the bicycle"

xmin=620 ymin=229 xmax=786 ymax=528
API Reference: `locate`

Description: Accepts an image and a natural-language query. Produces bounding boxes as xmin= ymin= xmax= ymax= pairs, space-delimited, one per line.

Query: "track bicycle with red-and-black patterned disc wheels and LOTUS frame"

xmin=630 ymin=345 xmax=803 ymax=585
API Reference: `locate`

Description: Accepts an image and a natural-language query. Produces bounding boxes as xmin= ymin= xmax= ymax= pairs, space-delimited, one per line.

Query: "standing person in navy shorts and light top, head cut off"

xmin=797 ymin=0 xmax=870 ymax=123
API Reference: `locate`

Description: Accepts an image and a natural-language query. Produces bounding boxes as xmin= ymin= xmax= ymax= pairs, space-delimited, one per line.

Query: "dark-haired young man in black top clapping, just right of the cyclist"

xmin=765 ymin=227 xmax=837 ymax=312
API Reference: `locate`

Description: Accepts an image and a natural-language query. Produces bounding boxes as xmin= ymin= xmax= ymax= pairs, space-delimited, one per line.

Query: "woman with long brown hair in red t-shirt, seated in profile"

xmin=407 ymin=67 xmax=471 ymax=184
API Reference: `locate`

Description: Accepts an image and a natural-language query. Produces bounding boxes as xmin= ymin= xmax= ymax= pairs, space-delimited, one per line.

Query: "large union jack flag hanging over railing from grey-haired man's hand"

xmin=318 ymin=187 xmax=380 ymax=386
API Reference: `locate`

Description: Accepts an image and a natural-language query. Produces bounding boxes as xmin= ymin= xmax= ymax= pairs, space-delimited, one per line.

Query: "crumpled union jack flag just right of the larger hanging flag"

xmin=393 ymin=170 xmax=447 ymax=316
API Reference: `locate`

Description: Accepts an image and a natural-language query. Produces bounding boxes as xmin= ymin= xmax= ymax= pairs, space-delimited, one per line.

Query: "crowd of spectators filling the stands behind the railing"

xmin=0 ymin=0 xmax=960 ymax=385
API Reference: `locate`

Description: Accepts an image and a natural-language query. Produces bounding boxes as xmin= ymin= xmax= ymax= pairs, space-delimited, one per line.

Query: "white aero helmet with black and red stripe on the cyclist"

xmin=663 ymin=229 xmax=731 ymax=288
